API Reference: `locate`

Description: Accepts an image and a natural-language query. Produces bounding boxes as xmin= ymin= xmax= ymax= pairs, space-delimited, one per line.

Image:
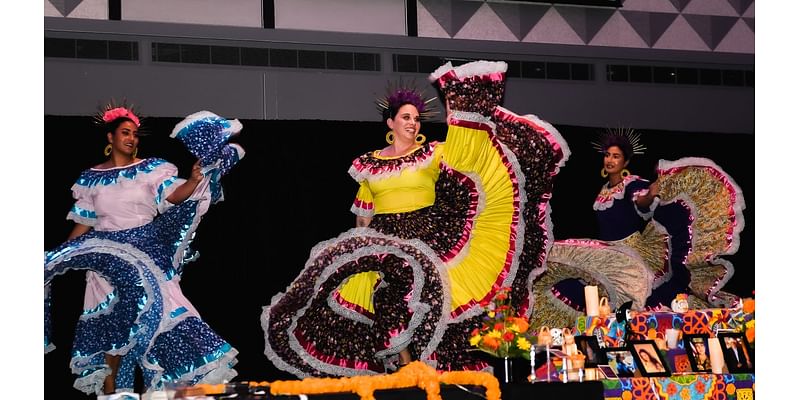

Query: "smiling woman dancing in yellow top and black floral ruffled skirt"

xmin=262 ymin=61 xmax=569 ymax=376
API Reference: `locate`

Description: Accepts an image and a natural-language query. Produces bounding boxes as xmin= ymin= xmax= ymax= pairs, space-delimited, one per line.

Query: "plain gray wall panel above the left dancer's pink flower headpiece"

xmin=44 ymin=61 xmax=264 ymax=119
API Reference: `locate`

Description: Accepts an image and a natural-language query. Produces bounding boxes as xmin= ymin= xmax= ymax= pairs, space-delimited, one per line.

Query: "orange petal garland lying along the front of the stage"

xmin=250 ymin=361 xmax=500 ymax=400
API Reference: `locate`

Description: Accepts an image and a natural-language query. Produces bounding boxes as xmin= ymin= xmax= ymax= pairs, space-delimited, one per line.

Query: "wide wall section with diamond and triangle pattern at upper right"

xmin=417 ymin=0 xmax=755 ymax=54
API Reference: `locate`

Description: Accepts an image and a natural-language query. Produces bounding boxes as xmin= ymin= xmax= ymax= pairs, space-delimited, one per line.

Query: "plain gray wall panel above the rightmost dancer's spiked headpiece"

xmin=505 ymin=78 xmax=755 ymax=133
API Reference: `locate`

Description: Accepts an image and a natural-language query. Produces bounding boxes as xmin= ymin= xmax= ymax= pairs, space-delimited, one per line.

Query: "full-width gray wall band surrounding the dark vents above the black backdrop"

xmin=44 ymin=18 xmax=755 ymax=133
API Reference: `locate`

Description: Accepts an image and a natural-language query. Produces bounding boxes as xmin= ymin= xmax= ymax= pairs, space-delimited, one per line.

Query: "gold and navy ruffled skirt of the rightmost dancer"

xmin=531 ymin=158 xmax=745 ymax=327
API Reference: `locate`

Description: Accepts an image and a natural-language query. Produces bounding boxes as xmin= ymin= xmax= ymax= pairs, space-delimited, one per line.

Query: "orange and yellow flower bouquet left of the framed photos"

xmin=469 ymin=287 xmax=533 ymax=360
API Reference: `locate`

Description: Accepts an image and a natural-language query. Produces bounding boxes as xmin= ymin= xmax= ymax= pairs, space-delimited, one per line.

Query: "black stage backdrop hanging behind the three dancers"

xmin=43 ymin=116 xmax=755 ymax=398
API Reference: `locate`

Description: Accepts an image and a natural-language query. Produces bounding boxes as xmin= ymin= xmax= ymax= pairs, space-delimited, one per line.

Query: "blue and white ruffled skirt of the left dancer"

xmin=45 ymin=201 xmax=237 ymax=394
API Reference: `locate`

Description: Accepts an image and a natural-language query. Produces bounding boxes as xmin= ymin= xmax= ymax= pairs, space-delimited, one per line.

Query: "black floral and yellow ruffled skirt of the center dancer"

xmin=262 ymin=108 xmax=568 ymax=377
